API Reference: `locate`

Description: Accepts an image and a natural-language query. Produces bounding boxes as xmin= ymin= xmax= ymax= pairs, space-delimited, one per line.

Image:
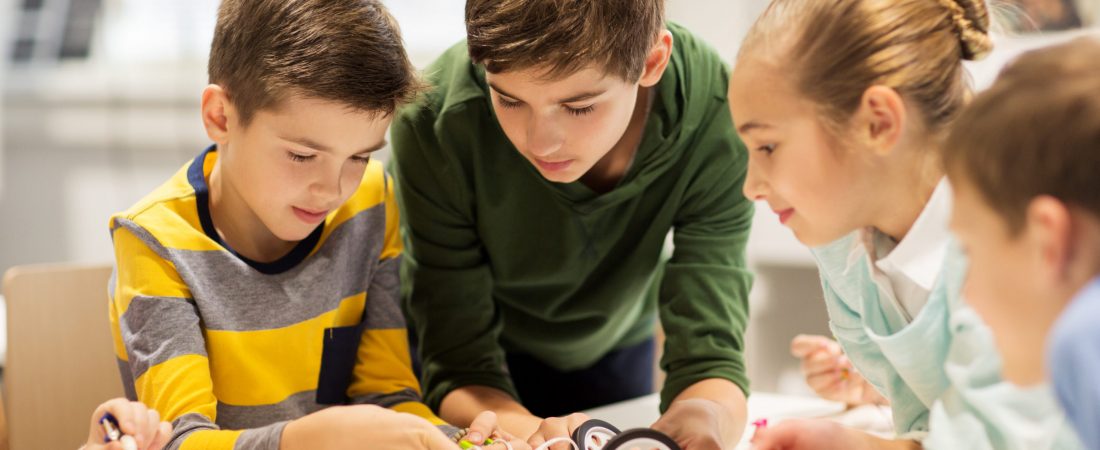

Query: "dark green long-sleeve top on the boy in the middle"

xmin=391 ymin=24 xmax=752 ymax=410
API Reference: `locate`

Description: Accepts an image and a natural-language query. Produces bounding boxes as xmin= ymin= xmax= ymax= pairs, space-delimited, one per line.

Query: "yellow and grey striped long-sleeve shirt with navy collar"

xmin=109 ymin=147 xmax=449 ymax=449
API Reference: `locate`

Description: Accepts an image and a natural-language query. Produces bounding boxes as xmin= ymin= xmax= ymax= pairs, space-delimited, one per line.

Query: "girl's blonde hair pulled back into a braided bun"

xmin=738 ymin=0 xmax=992 ymax=135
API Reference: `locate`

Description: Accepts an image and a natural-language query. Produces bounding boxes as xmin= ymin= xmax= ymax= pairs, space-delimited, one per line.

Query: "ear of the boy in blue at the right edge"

xmin=1024 ymin=196 xmax=1075 ymax=282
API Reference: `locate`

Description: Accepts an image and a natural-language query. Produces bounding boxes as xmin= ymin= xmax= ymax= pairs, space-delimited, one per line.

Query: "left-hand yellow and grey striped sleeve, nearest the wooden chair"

xmin=109 ymin=218 xmax=285 ymax=450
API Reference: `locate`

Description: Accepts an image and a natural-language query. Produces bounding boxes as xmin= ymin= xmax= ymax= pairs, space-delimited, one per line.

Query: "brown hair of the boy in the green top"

xmin=466 ymin=0 xmax=664 ymax=83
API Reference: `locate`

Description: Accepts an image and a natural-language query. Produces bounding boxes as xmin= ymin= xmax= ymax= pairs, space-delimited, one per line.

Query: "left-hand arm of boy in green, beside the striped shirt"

xmin=391 ymin=109 xmax=525 ymax=426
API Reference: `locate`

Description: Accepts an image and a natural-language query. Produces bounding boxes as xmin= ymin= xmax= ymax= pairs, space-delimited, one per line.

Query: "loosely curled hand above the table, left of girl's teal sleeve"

xmin=791 ymin=334 xmax=889 ymax=406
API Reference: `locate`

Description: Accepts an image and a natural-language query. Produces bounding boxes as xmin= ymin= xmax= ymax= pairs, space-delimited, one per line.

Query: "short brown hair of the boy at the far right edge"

xmin=943 ymin=37 xmax=1100 ymax=233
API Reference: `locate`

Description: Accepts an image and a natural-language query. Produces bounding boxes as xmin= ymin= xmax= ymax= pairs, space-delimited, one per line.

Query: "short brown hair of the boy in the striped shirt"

xmin=208 ymin=0 xmax=420 ymax=124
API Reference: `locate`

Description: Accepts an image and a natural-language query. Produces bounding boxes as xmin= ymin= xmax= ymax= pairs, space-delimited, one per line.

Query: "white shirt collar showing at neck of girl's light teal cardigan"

xmin=862 ymin=177 xmax=953 ymax=321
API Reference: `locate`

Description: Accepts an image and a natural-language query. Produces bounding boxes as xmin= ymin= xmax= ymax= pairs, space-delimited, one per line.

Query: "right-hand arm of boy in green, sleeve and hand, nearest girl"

xmin=658 ymin=94 xmax=754 ymax=448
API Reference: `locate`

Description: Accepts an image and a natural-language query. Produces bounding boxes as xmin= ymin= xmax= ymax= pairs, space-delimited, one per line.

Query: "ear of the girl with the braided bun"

xmin=855 ymin=85 xmax=906 ymax=156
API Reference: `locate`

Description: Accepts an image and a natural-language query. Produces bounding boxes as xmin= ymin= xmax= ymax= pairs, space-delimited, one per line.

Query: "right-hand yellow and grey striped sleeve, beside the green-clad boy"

xmin=348 ymin=173 xmax=457 ymax=435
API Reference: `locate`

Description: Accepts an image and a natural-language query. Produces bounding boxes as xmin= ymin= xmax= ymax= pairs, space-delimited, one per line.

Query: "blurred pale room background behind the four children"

xmin=0 ymin=0 xmax=1100 ymax=393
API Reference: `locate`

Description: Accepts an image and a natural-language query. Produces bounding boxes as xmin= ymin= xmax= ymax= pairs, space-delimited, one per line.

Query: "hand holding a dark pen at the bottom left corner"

xmin=84 ymin=398 xmax=172 ymax=450
